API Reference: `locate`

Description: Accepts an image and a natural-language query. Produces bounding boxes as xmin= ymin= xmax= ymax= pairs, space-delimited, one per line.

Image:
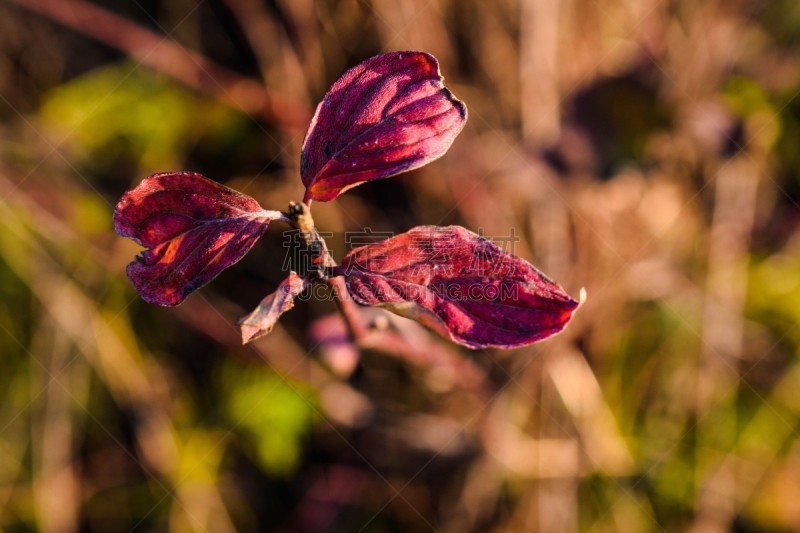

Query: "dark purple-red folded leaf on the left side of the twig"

xmin=114 ymin=172 xmax=282 ymax=305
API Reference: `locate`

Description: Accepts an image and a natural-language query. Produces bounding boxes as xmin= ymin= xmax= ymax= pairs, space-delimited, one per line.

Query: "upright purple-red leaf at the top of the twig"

xmin=300 ymin=52 xmax=467 ymax=202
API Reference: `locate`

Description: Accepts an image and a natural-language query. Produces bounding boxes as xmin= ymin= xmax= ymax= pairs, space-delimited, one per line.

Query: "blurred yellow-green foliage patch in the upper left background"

xmin=40 ymin=61 xmax=247 ymax=169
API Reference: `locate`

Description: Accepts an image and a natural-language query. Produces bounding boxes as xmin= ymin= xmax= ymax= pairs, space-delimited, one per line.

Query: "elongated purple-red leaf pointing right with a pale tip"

xmin=334 ymin=226 xmax=578 ymax=348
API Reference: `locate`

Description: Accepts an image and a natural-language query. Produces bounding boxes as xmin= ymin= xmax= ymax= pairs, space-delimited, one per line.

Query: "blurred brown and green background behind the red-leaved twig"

xmin=0 ymin=0 xmax=800 ymax=532
